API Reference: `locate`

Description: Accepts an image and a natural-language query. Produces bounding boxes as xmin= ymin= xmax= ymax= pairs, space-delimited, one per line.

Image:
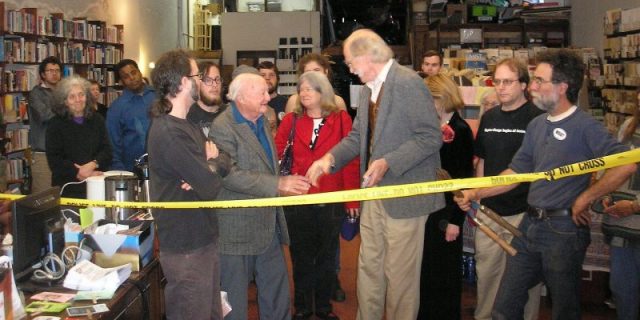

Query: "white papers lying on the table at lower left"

xmin=63 ymin=260 xmax=131 ymax=291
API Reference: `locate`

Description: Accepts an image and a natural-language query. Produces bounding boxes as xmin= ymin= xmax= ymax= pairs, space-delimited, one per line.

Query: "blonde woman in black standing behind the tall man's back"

xmin=418 ymin=74 xmax=473 ymax=319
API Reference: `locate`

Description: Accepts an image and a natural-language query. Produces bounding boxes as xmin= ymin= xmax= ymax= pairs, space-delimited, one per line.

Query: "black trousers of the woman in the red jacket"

xmin=284 ymin=203 xmax=345 ymax=312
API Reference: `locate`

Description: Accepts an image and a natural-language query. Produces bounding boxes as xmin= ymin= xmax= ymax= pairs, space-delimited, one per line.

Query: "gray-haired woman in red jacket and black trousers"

xmin=275 ymin=72 xmax=359 ymax=320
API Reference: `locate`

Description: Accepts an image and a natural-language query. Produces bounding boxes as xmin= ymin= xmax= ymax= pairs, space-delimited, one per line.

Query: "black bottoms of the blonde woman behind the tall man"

xmin=418 ymin=210 xmax=462 ymax=320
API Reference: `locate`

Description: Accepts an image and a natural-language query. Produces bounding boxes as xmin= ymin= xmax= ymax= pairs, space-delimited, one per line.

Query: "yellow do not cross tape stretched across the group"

xmin=0 ymin=149 xmax=640 ymax=209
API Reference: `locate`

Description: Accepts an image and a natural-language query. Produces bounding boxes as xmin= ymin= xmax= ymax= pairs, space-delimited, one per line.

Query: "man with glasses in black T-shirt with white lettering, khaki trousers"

xmin=474 ymin=58 xmax=543 ymax=320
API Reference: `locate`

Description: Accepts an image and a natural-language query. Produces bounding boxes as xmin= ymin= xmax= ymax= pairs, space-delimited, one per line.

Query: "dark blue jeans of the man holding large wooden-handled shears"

xmin=492 ymin=215 xmax=591 ymax=320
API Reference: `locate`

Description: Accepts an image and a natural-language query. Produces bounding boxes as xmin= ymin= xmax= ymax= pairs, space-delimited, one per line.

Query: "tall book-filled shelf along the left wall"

xmin=0 ymin=1 xmax=124 ymax=189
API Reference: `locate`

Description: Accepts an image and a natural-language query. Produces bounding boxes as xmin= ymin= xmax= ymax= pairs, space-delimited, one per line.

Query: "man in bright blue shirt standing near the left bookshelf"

xmin=107 ymin=59 xmax=155 ymax=171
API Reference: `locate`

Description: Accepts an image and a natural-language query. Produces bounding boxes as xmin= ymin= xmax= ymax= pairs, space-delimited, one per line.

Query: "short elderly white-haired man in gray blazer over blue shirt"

xmin=209 ymin=73 xmax=310 ymax=320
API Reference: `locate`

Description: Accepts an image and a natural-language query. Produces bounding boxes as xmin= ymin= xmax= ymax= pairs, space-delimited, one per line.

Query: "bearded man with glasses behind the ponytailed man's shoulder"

xmin=187 ymin=61 xmax=227 ymax=137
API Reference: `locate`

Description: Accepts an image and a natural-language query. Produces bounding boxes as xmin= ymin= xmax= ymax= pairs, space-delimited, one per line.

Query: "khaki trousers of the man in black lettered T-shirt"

xmin=474 ymin=213 xmax=542 ymax=320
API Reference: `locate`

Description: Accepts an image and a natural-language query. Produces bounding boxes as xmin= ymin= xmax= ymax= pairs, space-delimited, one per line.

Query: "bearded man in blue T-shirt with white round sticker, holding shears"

xmin=455 ymin=49 xmax=636 ymax=320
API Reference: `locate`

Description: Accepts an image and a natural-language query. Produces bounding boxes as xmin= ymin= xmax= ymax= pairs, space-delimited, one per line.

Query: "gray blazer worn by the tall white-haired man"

xmin=330 ymin=61 xmax=445 ymax=218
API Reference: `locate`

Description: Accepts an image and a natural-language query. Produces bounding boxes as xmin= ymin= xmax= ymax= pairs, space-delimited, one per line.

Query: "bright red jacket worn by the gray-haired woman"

xmin=275 ymin=110 xmax=360 ymax=209
